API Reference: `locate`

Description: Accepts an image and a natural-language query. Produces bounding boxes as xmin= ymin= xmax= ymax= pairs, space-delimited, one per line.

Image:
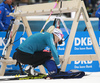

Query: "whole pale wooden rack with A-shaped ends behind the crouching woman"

xmin=0 ymin=0 xmax=100 ymax=76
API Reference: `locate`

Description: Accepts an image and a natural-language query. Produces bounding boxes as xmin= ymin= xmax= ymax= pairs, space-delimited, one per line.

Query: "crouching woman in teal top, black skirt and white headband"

xmin=13 ymin=26 xmax=64 ymax=73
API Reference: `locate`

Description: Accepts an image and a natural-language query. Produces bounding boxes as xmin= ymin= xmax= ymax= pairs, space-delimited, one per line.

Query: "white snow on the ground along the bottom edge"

xmin=0 ymin=72 xmax=100 ymax=83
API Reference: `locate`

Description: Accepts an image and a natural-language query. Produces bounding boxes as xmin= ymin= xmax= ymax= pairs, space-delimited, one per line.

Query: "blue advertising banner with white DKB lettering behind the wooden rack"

xmin=0 ymin=31 xmax=100 ymax=72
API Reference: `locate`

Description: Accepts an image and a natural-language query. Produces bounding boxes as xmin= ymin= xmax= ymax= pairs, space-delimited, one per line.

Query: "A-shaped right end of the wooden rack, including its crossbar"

xmin=61 ymin=1 xmax=100 ymax=71
